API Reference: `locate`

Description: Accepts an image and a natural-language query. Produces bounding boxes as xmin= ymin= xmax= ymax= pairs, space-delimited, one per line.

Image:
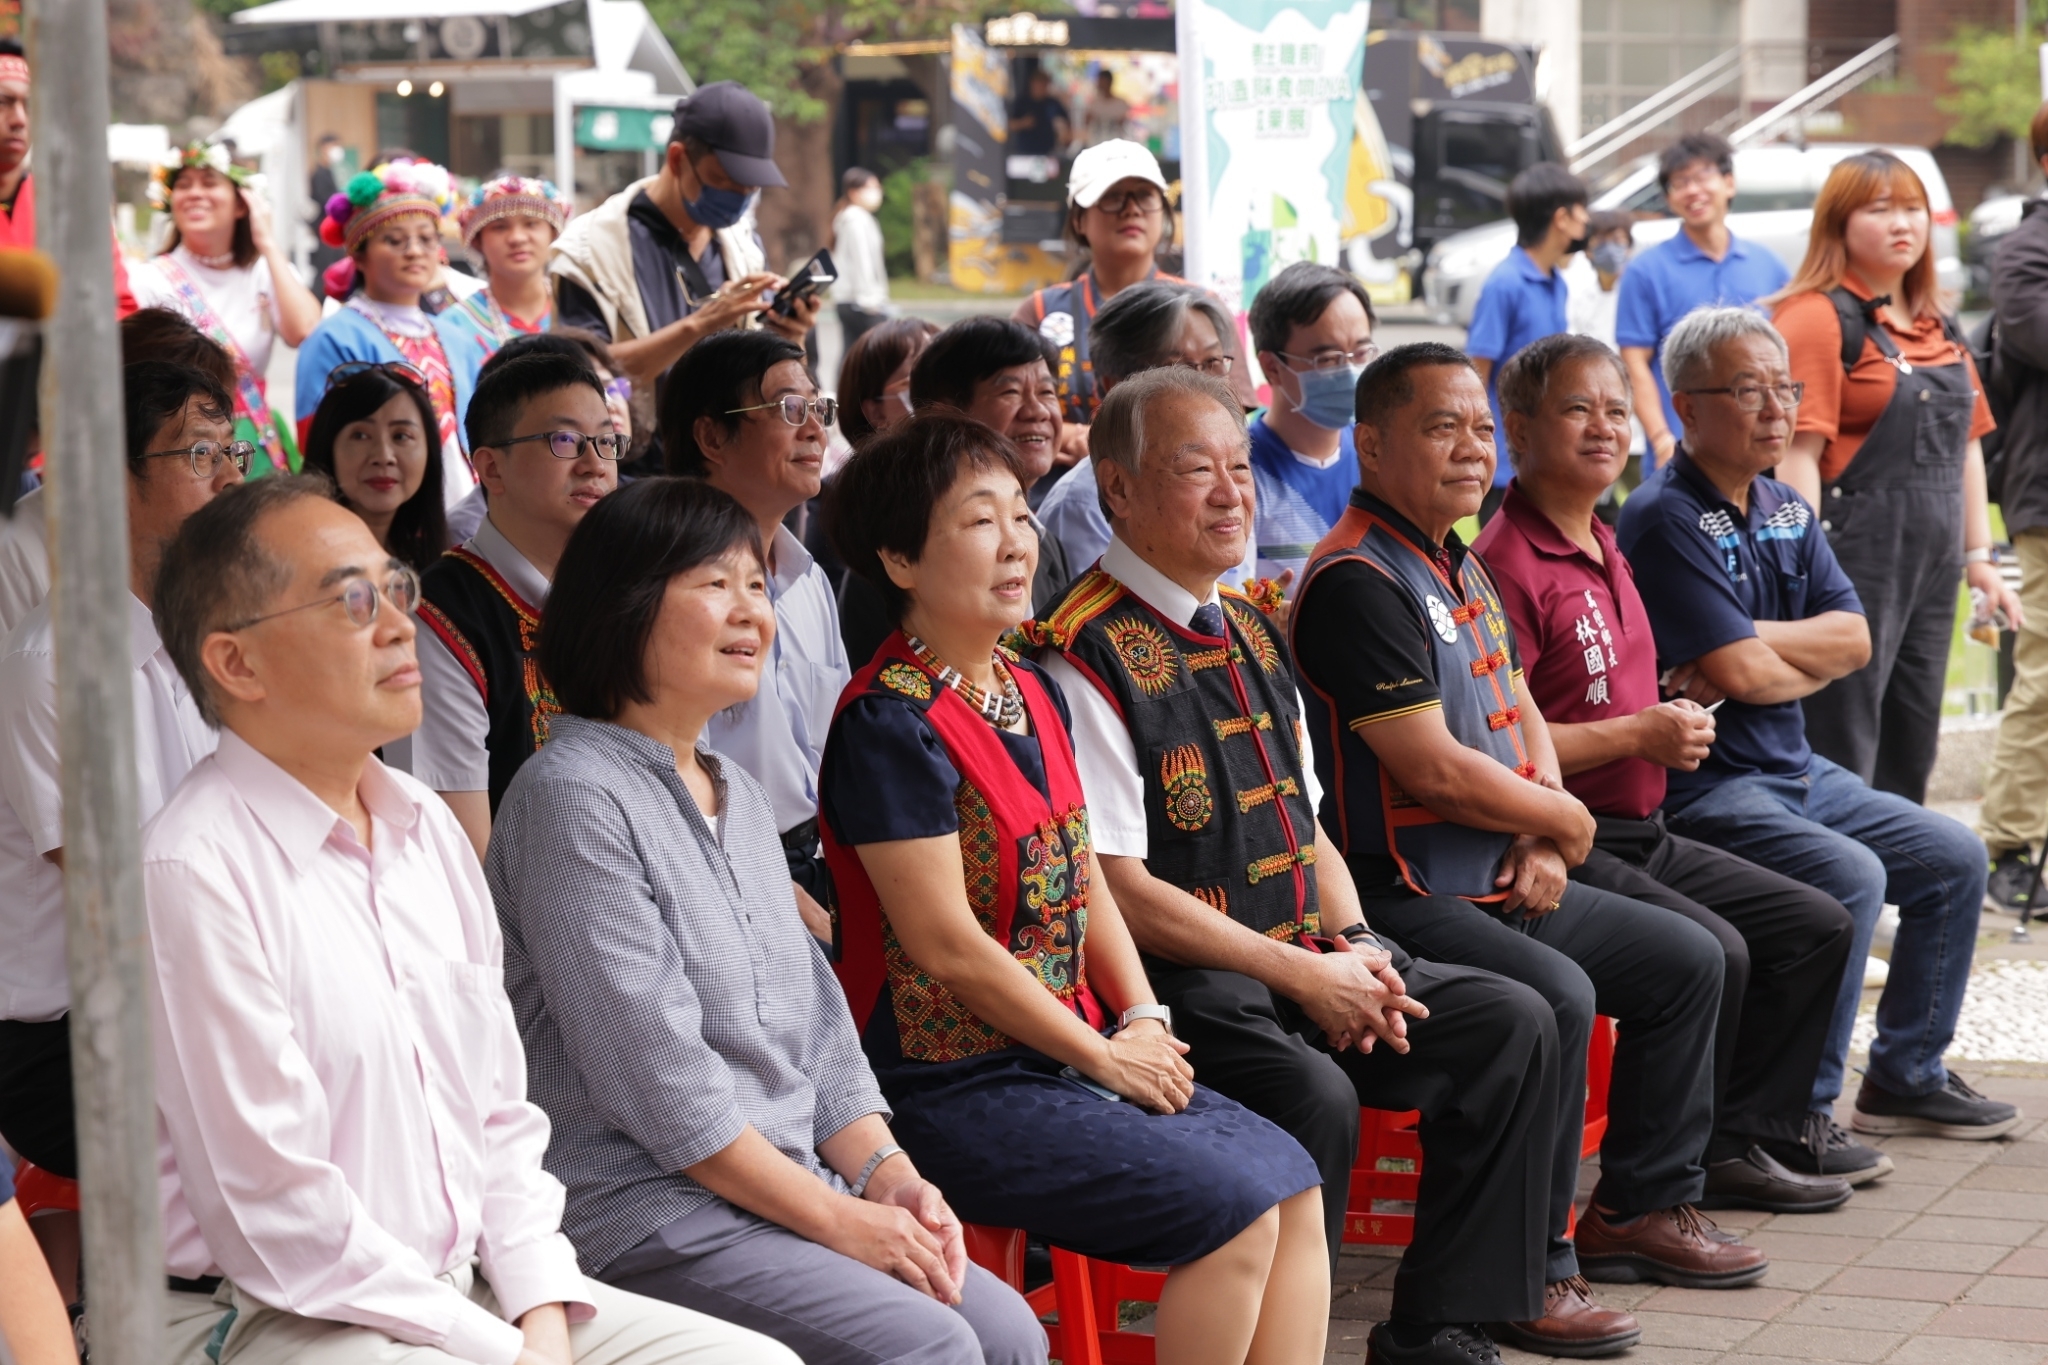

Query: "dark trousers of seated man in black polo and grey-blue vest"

xmin=1364 ymin=882 xmax=1722 ymax=1279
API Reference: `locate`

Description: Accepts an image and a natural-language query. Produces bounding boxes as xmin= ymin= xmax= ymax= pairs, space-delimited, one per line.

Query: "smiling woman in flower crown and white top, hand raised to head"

xmin=129 ymin=143 xmax=319 ymax=477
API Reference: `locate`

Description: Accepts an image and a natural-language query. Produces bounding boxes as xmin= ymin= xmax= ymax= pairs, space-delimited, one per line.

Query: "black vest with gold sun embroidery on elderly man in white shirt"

xmin=1036 ymin=569 xmax=1321 ymax=943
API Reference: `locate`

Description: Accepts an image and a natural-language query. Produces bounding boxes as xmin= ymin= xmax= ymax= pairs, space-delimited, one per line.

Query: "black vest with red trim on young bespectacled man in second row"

xmin=420 ymin=546 xmax=561 ymax=814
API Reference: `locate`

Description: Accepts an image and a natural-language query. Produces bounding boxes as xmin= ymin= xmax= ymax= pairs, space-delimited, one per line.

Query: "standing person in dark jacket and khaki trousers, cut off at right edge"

xmin=1976 ymin=104 xmax=2048 ymax=913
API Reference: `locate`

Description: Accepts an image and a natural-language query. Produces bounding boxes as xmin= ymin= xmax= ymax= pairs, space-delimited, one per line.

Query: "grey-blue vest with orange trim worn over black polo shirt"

xmin=1288 ymin=503 xmax=1536 ymax=900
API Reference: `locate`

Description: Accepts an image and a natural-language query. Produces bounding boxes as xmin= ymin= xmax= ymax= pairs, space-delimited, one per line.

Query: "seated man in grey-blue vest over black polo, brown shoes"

xmin=1290 ymin=342 xmax=1767 ymax=1326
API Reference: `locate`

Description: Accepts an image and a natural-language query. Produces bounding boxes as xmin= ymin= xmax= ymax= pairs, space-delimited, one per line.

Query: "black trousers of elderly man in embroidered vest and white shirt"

xmin=1145 ymin=950 xmax=1556 ymax=1322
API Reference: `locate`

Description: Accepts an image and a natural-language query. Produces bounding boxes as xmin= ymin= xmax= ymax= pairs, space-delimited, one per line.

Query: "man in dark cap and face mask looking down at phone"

xmin=547 ymin=80 xmax=819 ymax=385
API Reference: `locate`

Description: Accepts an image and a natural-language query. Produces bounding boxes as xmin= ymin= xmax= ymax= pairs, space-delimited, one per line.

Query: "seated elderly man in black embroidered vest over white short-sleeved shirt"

xmin=1040 ymin=368 xmax=1638 ymax=1365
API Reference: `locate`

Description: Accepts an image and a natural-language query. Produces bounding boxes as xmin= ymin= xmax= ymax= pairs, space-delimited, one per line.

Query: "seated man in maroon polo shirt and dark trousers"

xmin=1473 ymin=334 xmax=1890 ymax=1214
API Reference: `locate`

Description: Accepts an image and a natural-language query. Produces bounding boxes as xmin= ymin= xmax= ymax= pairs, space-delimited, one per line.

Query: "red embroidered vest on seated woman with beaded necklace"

xmin=819 ymin=632 xmax=1106 ymax=1062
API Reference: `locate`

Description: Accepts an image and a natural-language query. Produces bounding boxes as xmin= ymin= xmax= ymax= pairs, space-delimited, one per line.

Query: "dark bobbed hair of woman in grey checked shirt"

xmin=535 ymin=475 xmax=766 ymax=720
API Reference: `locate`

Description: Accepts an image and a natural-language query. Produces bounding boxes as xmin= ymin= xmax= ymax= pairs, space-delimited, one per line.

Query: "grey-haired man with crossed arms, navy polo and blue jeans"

xmin=1618 ymin=307 xmax=2019 ymax=1138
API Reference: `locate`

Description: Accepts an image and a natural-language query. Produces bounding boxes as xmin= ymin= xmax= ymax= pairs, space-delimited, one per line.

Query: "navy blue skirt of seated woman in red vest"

xmin=879 ymin=1048 xmax=1323 ymax=1265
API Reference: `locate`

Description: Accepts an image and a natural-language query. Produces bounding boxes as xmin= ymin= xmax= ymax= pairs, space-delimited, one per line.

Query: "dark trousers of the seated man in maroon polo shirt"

xmin=1571 ymin=810 xmax=1855 ymax=1160
